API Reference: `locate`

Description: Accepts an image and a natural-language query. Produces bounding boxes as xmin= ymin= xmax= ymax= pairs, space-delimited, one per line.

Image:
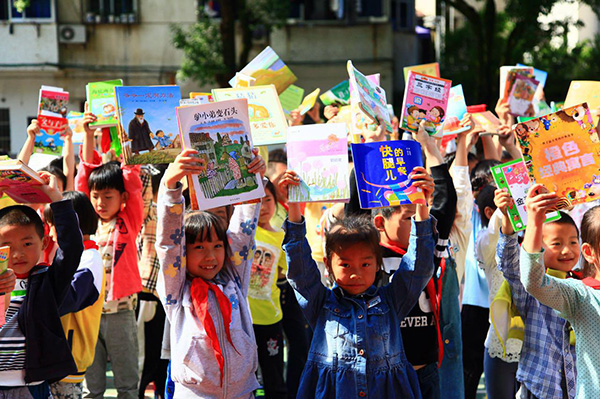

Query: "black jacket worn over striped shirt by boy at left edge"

xmin=17 ymin=200 xmax=83 ymax=383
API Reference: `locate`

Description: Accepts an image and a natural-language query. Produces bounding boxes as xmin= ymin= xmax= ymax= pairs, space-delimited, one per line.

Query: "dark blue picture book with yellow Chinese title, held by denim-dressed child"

xmin=352 ymin=140 xmax=425 ymax=209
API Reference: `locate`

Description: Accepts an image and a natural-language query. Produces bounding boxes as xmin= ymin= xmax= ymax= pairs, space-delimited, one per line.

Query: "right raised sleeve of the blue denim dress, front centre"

xmin=382 ymin=217 xmax=437 ymax=320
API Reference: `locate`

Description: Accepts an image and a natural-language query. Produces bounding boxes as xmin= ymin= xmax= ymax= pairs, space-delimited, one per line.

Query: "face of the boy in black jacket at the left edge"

xmin=0 ymin=225 xmax=48 ymax=274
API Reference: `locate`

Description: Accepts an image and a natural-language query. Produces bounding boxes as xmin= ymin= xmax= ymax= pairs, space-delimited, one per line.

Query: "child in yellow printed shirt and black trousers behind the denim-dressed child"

xmin=248 ymin=181 xmax=287 ymax=398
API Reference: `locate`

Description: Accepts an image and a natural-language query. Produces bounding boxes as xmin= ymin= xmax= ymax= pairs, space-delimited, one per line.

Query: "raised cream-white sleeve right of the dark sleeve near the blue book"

xmin=450 ymin=166 xmax=473 ymax=283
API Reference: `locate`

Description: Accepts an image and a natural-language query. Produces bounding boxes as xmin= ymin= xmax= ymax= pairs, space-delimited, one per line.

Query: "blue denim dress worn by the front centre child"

xmin=283 ymin=218 xmax=436 ymax=399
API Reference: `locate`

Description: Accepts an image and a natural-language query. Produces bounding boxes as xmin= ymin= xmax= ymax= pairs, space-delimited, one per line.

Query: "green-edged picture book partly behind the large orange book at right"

xmin=492 ymin=158 xmax=560 ymax=231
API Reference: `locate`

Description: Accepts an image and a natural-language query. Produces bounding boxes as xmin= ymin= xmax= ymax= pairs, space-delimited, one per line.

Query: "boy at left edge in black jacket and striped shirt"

xmin=0 ymin=177 xmax=83 ymax=399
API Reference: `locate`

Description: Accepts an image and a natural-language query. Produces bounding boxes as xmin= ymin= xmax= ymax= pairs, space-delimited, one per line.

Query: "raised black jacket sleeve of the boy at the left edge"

xmin=49 ymin=200 xmax=83 ymax=303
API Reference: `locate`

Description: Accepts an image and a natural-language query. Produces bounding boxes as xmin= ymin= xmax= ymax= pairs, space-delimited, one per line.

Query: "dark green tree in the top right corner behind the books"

xmin=442 ymin=0 xmax=600 ymax=106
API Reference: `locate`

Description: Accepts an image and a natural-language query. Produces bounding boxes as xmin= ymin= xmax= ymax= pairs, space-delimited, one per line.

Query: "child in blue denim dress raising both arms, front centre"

xmin=281 ymin=171 xmax=435 ymax=398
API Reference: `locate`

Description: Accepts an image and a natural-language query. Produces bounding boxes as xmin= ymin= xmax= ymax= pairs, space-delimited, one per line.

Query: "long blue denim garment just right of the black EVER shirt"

xmin=439 ymin=259 xmax=465 ymax=399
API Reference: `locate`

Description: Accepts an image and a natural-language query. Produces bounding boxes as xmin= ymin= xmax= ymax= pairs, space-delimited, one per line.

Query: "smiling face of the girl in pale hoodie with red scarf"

xmin=185 ymin=227 xmax=225 ymax=280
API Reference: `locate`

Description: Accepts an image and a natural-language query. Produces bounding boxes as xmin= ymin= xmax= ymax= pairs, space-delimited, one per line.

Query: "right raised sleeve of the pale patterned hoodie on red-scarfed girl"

xmin=227 ymin=202 xmax=260 ymax=297
